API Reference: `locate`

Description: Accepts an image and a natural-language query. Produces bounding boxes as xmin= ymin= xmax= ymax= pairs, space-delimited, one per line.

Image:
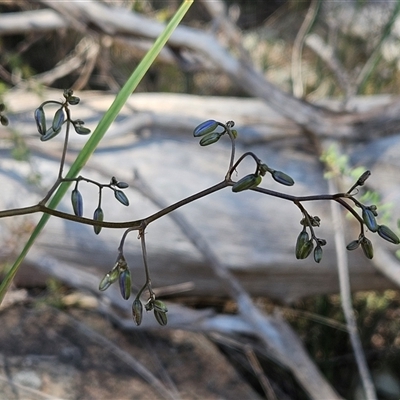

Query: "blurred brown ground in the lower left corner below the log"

xmin=0 ymin=301 xmax=259 ymax=400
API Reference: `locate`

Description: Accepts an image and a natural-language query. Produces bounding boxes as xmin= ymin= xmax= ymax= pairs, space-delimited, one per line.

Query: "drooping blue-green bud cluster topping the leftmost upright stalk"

xmin=34 ymin=89 xmax=90 ymax=142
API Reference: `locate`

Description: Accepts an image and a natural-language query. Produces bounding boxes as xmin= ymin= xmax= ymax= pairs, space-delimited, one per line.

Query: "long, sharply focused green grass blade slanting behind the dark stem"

xmin=0 ymin=0 xmax=194 ymax=304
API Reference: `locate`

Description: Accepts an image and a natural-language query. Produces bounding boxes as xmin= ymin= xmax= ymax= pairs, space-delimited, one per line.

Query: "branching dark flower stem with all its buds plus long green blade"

xmin=0 ymin=1 xmax=400 ymax=325
